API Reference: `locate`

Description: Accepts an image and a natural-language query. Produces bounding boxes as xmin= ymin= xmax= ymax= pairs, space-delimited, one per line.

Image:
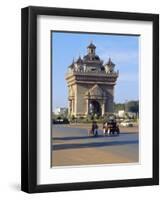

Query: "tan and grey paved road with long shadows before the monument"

xmin=52 ymin=125 xmax=139 ymax=166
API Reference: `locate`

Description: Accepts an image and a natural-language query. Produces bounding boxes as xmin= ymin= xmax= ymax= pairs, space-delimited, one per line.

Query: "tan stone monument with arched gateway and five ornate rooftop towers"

xmin=66 ymin=42 xmax=119 ymax=117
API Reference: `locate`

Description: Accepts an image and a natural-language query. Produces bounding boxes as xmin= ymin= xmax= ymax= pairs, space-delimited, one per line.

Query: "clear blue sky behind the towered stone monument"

xmin=52 ymin=32 xmax=139 ymax=110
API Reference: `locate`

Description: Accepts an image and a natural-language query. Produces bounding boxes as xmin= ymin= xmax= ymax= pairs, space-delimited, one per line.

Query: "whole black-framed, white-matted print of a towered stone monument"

xmin=21 ymin=6 xmax=159 ymax=193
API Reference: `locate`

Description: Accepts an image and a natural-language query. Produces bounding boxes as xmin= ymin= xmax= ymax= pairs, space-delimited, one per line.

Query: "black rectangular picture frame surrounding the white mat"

xmin=21 ymin=6 xmax=159 ymax=193
